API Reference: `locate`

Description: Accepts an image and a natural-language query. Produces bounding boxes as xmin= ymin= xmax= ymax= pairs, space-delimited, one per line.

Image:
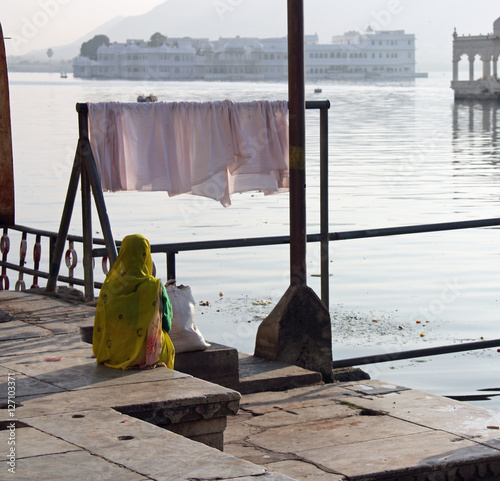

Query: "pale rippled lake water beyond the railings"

xmin=6 ymin=72 xmax=500 ymax=410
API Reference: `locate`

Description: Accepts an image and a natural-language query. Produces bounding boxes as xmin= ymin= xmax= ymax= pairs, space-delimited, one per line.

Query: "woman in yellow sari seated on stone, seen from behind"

xmin=92 ymin=234 xmax=175 ymax=369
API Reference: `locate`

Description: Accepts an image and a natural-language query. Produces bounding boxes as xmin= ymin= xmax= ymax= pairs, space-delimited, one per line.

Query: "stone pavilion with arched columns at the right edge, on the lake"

xmin=451 ymin=18 xmax=500 ymax=100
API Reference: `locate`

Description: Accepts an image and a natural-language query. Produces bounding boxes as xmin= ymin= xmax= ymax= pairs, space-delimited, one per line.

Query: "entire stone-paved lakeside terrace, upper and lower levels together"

xmin=0 ymin=291 xmax=500 ymax=481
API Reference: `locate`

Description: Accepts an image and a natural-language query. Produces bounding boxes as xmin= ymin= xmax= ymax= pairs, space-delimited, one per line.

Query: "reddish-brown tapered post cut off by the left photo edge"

xmin=0 ymin=24 xmax=15 ymax=225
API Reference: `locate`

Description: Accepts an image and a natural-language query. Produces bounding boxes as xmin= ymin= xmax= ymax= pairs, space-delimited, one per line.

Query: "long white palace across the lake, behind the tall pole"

xmin=73 ymin=27 xmax=425 ymax=81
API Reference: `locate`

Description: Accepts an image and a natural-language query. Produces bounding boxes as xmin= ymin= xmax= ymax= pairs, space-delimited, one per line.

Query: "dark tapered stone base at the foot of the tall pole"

xmin=255 ymin=286 xmax=332 ymax=380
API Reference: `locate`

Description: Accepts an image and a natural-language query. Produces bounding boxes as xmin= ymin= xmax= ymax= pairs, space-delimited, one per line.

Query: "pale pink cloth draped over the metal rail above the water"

xmin=88 ymin=100 xmax=288 ymax=206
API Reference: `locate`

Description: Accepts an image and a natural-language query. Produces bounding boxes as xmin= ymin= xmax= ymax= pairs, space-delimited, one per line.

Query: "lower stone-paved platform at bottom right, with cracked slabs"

xmin=224 ymin=381 xmax=500 ymax=481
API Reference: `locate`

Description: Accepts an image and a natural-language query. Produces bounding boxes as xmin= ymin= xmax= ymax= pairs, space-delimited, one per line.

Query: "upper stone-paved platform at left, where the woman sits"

xmin=0 ymin=291 xmax=290 ymax=481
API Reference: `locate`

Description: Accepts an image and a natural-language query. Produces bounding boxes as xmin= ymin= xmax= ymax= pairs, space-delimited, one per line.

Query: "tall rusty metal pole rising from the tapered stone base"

xmin=288 ymin=0 xmax=307 ymax=286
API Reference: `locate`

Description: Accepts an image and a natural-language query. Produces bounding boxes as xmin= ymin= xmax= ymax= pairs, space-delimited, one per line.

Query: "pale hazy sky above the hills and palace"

xmin=0 ymin=0 xmax=500 ymax=69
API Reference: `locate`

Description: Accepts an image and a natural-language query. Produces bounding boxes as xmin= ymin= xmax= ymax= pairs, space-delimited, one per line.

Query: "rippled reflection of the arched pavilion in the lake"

xmin=453 ymin=100 xmax=500 ymax=165
